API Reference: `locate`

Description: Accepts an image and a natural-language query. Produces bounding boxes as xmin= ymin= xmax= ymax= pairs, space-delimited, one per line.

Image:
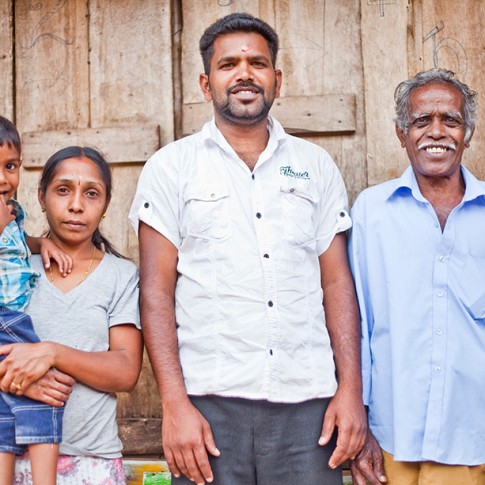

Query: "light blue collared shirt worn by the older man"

xmin=349 ymin=167 xmax=485 ymax=466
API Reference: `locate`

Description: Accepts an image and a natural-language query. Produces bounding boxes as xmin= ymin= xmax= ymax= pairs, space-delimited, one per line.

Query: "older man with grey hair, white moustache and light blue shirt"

xmin=350 ymin=69 xmax=485 ymax=485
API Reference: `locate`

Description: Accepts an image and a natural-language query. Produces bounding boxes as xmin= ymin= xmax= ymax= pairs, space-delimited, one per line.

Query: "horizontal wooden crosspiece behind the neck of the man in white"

xmin=183 ymin=94 xmax=355 ymax=135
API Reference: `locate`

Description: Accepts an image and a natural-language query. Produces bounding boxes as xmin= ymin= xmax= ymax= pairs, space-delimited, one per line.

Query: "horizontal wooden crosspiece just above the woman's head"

xmin=22 ymin=124 xmax=160 ymax=168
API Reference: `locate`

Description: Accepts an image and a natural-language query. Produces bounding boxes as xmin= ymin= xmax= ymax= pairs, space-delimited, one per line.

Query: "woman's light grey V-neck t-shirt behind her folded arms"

xmin=26 ymin=254 xmax=140 ymax=458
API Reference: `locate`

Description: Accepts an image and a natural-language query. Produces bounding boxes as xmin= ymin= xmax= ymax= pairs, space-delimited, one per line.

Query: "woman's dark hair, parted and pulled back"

xmin=39 ymin=146 xmax=125 ymax=258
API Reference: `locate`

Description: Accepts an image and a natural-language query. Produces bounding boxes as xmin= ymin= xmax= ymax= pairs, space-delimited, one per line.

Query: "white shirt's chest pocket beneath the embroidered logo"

xmin=280 ymin=185 xmax=319 ymax=245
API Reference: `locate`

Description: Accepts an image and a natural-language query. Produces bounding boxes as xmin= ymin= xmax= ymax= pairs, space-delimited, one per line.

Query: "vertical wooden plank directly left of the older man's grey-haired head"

xmin=360 ymin=0 xmax=408 ymax=185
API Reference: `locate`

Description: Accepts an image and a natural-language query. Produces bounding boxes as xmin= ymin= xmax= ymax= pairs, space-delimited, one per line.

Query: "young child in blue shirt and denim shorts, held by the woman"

xmin=0 ymin=116 xmax=71 ymax=485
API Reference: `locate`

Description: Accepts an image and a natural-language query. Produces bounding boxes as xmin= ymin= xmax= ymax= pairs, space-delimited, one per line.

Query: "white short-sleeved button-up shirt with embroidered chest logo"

xmin=130 ymin=119 xmax=351 ymax=402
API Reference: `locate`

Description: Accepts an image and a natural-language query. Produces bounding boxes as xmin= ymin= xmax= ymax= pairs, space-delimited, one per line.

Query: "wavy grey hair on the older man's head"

xmin=394 ymin=68 xmax=478 ymax=141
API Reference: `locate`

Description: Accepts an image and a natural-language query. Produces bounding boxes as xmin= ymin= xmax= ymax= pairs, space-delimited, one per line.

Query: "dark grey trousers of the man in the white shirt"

xmin=172 ymin=396 xmax=342 ymax=485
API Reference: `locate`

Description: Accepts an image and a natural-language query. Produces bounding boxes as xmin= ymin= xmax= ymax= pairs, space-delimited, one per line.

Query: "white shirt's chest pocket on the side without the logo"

xmin=181 ymin=184 xmax=231 ymax=241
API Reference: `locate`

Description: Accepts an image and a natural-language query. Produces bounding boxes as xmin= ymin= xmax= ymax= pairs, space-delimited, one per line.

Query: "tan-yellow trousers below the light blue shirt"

xmin=382 ymin=450 xmax=485 ymax=485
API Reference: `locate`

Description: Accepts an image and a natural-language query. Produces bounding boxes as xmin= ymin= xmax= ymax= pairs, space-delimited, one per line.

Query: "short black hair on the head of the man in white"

xmin=199 ymin=13 xmax=279 ymax=74
